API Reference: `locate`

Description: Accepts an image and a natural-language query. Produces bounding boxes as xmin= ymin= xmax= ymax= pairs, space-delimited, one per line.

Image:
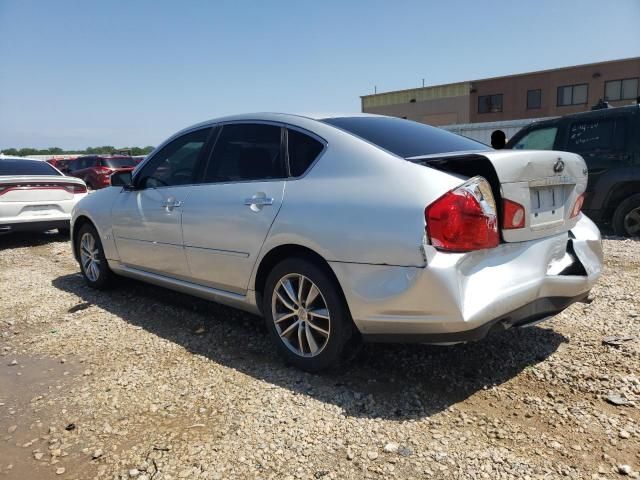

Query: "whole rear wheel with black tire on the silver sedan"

xmin=262 ymin=258 xmax=353 ymax=372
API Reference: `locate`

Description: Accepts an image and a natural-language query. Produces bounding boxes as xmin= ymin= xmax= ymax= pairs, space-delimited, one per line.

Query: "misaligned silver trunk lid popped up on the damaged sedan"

xmin=407 ymin=150 xmax=587 ymax=242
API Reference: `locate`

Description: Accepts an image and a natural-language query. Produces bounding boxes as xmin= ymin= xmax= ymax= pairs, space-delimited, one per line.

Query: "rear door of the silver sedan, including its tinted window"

xmin=182 ymin=123 xmax=287 ymax=293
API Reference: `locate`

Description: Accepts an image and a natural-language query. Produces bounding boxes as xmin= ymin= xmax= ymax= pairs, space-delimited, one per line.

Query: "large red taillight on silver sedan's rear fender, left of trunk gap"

xmin=424 ymin=177 xmax=499 ymax=252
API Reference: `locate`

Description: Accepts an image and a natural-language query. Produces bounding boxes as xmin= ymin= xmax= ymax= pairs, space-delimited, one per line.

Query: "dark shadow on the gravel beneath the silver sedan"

xmin=52 ymin=273 xmax=566 ymax=420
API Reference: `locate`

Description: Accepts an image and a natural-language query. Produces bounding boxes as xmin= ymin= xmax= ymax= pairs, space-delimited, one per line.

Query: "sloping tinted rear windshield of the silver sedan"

xmin=323 ymin=117 xmax=489 ymax=158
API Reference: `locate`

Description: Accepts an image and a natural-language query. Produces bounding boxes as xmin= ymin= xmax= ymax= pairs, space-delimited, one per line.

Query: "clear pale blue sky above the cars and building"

xmin=0 ymin=0 xmax=640 ymax=149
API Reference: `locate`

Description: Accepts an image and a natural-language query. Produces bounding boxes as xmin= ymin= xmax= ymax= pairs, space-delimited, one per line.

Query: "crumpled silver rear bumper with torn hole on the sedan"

xmin=331 ymin=215 xmax=602 ymax=343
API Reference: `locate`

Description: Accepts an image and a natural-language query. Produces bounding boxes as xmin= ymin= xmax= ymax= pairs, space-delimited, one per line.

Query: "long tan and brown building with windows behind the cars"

xmin=361 ymin=57 xmax=640 ymax=125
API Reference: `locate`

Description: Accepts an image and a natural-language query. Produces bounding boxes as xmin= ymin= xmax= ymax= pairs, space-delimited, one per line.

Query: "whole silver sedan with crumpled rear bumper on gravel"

xmin=72 ymin=113 xmax=602 ymax=371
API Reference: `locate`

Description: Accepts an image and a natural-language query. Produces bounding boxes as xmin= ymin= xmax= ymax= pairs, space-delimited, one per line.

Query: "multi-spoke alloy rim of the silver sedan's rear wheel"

xmin=271 ymin=273 xmax=331 ymax=357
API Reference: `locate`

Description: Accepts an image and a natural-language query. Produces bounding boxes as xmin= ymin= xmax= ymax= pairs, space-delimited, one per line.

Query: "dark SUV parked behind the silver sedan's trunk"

xmin=505 ymin=105 xmax=640 ymax=236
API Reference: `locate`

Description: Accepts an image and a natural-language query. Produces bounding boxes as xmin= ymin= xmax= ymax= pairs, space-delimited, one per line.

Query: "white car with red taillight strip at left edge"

xmin=0 ymin=156 xmax=87 ymax=234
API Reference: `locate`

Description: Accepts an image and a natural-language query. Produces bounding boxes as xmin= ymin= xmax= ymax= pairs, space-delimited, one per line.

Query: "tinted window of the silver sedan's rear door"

xmin=204 ymin=123 xmax=286 ymax=183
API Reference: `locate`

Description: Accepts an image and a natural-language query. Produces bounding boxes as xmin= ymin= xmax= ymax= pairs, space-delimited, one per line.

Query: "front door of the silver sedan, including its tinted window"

xmin=111 ymin=128 xmax=211 ymax=279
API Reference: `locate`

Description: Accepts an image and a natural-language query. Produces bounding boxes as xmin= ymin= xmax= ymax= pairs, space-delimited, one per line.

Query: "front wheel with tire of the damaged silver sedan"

xmin=76 ymin=224 xmax=113 ymax=289
